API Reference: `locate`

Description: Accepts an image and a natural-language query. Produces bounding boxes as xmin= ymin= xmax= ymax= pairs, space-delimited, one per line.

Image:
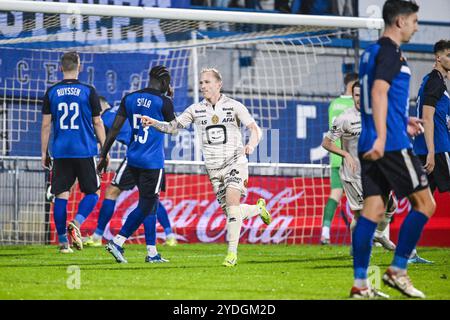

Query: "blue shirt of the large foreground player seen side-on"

xmin=358 ymin=37 xmax=412 ymax=152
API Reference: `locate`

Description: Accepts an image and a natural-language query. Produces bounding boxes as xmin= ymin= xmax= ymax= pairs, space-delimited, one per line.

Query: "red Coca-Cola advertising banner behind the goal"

xmin=51 ymin=173 xmax=450 ymax=246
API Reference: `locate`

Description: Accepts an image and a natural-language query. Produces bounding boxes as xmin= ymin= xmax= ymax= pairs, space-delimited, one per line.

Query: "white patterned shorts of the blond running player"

xmin=207 ymin=162 xmax=248 ymax=210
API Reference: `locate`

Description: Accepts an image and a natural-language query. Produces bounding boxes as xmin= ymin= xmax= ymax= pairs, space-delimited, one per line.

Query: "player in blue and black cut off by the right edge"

xmin=413 ymin=40 xmax=450 ymax=193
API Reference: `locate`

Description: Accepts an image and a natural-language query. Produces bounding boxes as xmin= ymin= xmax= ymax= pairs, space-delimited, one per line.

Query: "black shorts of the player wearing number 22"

xmin=51 ymin=158 xmax=100 ymax=195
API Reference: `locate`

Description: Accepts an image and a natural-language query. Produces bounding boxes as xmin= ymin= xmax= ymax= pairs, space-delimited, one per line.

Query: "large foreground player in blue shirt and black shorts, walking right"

xmin=350 ymin=0 xmax=436 ymax=298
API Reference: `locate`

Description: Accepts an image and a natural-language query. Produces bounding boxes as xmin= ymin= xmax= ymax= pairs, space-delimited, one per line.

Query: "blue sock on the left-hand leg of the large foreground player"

xmin=352 ymin=216 xmax=377 ymax=279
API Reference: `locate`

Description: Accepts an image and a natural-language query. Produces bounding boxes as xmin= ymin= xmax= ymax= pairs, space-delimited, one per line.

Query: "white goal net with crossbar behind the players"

xmin=0 ymin=0 xmax=382 ymax=243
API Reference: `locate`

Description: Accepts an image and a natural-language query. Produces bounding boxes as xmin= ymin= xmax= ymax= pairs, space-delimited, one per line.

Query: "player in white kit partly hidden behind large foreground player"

xmin=322 ymin=82 xmax=397 ymax=251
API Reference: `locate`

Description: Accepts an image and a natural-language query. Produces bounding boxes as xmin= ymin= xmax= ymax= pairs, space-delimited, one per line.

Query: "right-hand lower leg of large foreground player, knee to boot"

xmin=383 ymin=188 xmax=436 ymax=298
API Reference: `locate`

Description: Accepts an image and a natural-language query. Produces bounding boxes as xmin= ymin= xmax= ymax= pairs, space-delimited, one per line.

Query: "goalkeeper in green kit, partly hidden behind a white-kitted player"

xmin=320 ymin=72 xmax=358 ymax=245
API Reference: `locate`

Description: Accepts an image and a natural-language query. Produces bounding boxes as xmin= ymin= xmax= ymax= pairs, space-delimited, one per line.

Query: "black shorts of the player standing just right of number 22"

xmin=127 ymin=166 xmax=166 ymax=197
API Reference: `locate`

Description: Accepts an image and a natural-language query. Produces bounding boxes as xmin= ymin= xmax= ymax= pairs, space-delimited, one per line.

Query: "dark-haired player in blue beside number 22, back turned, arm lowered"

xmin=97 ymin=66 xmax=175 ymax=263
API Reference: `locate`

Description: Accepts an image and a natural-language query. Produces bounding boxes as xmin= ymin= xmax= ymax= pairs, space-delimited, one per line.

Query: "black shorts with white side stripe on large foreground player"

xmin=359 ymin=149 xmax=428 ymax=199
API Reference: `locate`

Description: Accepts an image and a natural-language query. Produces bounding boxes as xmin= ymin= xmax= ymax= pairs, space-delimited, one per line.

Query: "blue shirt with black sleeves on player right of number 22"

xmin=118 ymin=88 xmax=175 ymax=169
